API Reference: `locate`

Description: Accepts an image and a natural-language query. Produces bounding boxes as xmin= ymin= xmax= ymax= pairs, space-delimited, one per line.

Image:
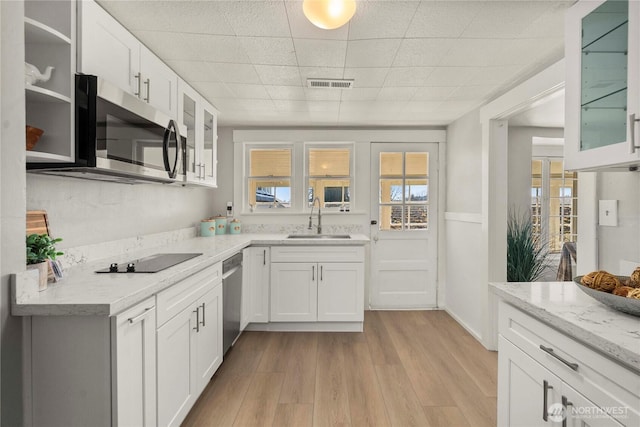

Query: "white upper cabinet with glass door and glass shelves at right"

xmin=565 ymin=0 xmax=640 ymax=170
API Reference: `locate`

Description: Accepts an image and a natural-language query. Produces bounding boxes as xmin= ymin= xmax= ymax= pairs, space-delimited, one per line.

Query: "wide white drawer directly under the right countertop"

xmin=499 ymin=301 xmax=640 ymax=425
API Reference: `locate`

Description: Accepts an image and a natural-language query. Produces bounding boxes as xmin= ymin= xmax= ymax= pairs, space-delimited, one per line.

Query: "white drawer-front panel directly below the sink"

xmin=271 ymin=246 xmax=364 ymax=262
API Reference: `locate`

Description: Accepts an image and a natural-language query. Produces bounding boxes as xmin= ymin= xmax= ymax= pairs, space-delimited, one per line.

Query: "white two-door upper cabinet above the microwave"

xmin=78 ymin=0 xmax=178 ymax=117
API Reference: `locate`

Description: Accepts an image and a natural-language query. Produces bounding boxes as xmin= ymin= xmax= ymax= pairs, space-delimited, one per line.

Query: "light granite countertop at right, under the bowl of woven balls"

xmin=490 ymin=282 xmax=640 ymax=371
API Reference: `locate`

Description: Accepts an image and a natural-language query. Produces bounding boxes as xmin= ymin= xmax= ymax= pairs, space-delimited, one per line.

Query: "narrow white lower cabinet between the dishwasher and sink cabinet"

xmin=240 ymin=246 xmax=271 ymax=330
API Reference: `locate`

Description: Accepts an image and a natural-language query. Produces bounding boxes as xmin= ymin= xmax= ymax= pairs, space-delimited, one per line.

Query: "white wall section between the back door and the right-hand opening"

xmin=444 ymin=110 xmax=485 ymax=338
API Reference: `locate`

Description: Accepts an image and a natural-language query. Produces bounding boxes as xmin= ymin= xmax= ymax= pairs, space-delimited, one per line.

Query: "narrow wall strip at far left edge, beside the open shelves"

xmin=0 ymin=1 xmax=26 ymax=426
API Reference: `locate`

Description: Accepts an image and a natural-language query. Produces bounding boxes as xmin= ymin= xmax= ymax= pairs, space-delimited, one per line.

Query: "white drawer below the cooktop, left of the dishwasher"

xmin=156 ymin=262 xmax=222 ymax=327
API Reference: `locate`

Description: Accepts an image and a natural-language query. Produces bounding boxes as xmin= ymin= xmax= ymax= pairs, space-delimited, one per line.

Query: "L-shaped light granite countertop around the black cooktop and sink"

xmin=11 ymin=234 xmax=369 ymax=316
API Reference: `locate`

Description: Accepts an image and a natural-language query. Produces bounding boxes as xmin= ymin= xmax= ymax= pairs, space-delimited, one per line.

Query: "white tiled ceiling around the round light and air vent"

xmin=99 ymin=0 xmax=573 ymax=126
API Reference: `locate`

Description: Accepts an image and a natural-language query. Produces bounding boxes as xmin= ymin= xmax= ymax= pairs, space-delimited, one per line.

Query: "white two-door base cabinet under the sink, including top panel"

xmin=270 ymin=246 xmax=364 ymax=322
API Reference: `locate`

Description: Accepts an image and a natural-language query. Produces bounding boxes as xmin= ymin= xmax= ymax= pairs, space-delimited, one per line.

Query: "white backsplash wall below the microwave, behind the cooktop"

xmin=27 ymin=174 xmax=214 ymax=249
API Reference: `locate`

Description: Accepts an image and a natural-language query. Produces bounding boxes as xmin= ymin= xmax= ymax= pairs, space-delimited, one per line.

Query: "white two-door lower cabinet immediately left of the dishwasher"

xmin=158 ymin=265 xmax=222 ymax=426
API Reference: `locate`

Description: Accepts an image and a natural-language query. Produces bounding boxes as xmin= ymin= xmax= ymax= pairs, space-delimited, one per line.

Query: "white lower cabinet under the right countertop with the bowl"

xmin=498 ymin=302 xmax=640 ymax=427
